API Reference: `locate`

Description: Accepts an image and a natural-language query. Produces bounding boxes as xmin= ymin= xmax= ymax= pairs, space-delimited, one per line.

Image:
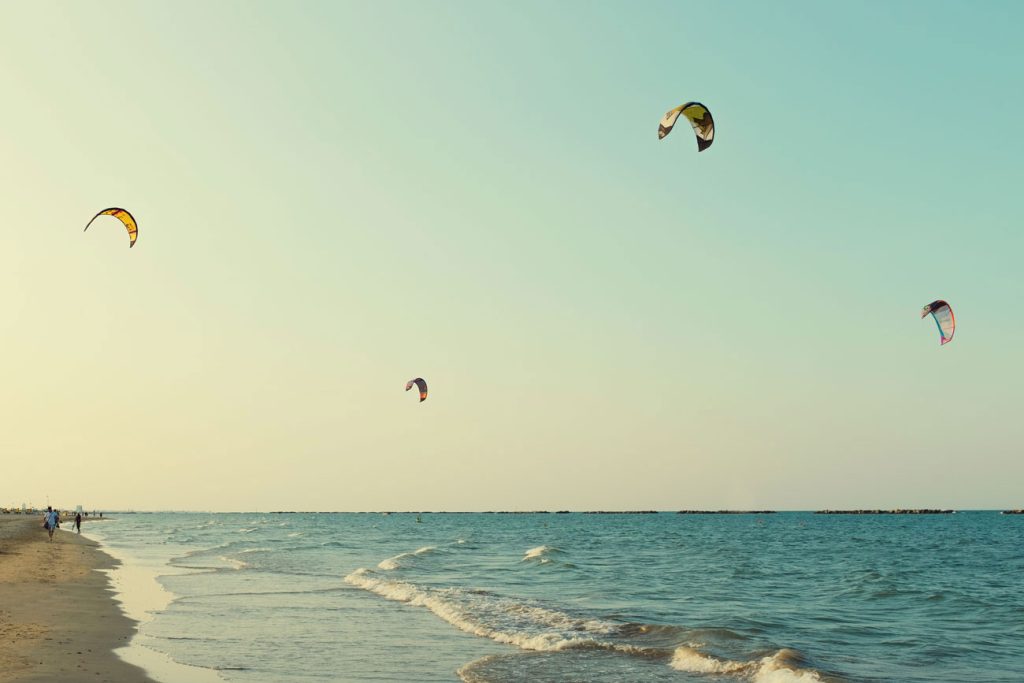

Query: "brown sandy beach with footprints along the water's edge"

xmin=0 ymin=515 xmax=152 ymax=683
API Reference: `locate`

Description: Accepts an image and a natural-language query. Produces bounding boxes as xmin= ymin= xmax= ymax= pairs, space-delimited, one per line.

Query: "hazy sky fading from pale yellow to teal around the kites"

xmin=0 ymin=0 xmax=1024 ymax=511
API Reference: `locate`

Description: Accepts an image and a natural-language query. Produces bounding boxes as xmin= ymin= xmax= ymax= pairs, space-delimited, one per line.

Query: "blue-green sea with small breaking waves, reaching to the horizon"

xmin=86 ymin=512 xmax=1024 ymax=683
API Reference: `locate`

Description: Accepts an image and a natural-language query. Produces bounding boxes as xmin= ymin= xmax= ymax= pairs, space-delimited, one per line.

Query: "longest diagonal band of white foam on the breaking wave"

xmin=345 ymin=568 xmax=614 ymax=651
